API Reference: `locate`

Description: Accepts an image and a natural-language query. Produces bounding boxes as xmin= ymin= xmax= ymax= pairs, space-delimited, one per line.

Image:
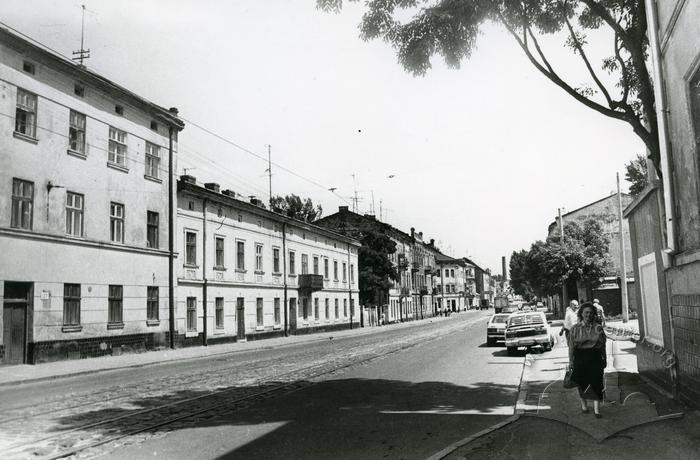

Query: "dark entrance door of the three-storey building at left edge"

xmin=2 ymin=282 xmax=32 ymax=364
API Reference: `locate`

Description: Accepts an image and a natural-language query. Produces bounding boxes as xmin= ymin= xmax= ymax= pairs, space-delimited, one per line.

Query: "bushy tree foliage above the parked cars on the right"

xmin=510 ymin=219 xmax=611 ymax=298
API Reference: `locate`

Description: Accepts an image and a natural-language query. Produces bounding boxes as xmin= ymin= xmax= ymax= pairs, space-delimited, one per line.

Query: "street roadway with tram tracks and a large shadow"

xmin=0 ymin=311 xmax=524 ymax=458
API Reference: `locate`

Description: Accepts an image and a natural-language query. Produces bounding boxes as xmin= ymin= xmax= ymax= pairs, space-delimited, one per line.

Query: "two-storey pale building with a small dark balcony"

xmin=176 ymin=176 xmax=360 ymax=344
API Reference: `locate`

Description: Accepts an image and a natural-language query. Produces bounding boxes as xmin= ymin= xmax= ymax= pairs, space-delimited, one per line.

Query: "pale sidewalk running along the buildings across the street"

xmin=0 ymin=317 xmax=449 ymax=387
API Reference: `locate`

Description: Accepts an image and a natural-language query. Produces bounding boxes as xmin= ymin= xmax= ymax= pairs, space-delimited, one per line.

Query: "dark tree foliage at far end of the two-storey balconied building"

xmin=357 ymin=228 xmax=399 ymax=305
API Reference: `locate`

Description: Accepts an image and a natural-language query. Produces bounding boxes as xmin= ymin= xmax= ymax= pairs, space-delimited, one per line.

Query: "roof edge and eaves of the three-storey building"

xmin=0 ymin=26 xmax=185 ymax=130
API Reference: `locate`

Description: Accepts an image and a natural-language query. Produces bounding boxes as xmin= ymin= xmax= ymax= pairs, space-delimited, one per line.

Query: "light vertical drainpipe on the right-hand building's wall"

xmin=645 ymin=0 xmax=676 ymax=253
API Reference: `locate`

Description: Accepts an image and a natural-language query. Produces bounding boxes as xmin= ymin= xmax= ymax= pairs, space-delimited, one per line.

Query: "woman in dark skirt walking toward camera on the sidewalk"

xmin=569 ymin=302 xmax=607 ymax=418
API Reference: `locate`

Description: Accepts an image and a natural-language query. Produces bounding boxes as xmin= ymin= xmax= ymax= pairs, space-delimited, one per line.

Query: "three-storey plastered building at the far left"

xmin=0 ymin=28 xmax=184 ymax=363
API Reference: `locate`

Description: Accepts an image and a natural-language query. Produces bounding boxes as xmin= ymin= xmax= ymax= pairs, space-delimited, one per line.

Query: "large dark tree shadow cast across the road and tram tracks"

xmin=47 ymin=378 xmax=518 ymax=458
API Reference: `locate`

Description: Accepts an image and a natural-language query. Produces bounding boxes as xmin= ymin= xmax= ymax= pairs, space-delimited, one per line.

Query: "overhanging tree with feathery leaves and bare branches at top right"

xmin=317 ymin=0 xmax=661 ymax=177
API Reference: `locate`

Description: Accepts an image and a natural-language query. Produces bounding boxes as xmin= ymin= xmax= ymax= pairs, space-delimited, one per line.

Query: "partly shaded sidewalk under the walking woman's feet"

xmin=440 ymin=321 xmax=700 ymax=459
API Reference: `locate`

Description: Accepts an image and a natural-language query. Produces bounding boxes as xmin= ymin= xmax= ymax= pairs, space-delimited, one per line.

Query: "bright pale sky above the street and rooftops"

xmin=0 ymin=0 xmax=644 ymax=273
